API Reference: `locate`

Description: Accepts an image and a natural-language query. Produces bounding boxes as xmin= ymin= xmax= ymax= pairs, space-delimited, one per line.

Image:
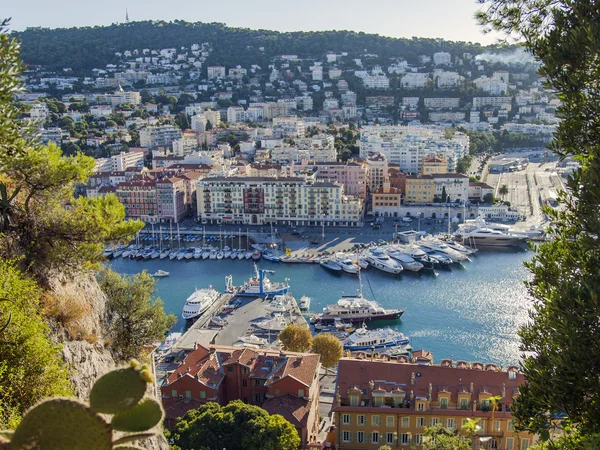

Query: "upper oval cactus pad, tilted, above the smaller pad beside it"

xmin=90 ymin=367 xmax=146 ymax=414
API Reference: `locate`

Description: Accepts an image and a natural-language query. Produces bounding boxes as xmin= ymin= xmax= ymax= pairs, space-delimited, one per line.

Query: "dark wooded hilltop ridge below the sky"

xmin=13 ymin=20 xmax=494 ymax=72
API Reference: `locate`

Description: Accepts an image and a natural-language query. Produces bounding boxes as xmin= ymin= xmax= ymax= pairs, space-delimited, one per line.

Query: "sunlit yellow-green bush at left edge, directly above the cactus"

xmin=0 ymin=259 xmax=71 ymax=429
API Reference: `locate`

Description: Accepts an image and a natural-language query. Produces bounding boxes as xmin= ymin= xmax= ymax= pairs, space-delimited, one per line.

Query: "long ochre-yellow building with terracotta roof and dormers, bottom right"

xmin=333 ymin=352 xmax=534 ymax=450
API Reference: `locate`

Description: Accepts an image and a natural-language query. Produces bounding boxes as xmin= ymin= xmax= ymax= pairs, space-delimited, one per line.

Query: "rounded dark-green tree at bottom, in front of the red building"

xmin=173 ymin=400 xmax=300 ymax=450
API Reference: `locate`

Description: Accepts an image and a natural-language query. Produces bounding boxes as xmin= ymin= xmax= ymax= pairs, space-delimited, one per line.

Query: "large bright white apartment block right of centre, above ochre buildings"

xmin=360 ymin=125 xmax=469 ymax=174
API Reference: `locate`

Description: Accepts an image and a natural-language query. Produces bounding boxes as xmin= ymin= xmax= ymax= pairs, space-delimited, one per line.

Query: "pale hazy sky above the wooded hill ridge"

xmin=0 ymin=0 xmax=493 ymax=44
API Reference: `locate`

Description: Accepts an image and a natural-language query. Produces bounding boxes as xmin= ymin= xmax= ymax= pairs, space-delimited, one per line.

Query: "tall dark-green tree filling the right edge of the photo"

xmin=478 ymin=0 xmax=600 ymax=439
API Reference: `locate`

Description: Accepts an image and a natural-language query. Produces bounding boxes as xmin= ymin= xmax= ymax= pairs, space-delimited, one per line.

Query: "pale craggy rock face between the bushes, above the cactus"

xmin=50 ymin=275 xmax=169 ymax=450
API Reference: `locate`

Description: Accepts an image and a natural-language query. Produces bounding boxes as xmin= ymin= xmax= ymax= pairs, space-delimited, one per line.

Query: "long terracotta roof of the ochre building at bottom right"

xmin=337 ymin=358 xmax=525 ymax=403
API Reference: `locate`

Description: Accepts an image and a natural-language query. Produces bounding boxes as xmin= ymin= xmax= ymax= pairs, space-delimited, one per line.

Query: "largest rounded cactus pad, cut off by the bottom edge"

xmin=10 ymin=398 xmax=112 ymax=450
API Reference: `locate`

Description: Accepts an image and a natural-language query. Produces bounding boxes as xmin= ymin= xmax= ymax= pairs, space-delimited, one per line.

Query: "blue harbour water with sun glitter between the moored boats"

xmin=111 ymin=250 xmax=532 ymax=366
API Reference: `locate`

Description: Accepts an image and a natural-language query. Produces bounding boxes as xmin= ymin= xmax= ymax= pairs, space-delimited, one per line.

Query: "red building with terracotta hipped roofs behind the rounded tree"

xmin=160 ymin=345 xmax=321 ymax=448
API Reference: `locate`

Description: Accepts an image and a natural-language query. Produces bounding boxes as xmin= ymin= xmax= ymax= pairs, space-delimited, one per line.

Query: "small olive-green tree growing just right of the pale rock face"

xmin=98 ymin=267 xmax=177 ymax=360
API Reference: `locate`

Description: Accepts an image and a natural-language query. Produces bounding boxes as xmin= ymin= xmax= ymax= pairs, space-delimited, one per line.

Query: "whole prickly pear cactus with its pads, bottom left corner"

xmin=0 ymin=361 xmax=164 ymax=450
